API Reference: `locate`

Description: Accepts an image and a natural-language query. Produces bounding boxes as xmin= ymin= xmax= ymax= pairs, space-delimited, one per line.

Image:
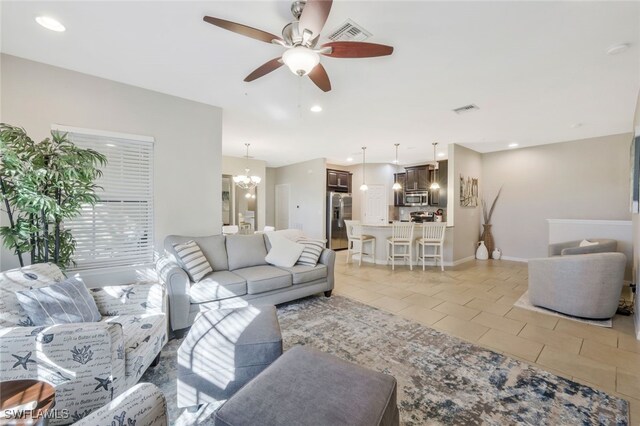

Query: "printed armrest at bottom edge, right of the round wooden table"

xmin=75 ymin=383 xmax=169 ymax=426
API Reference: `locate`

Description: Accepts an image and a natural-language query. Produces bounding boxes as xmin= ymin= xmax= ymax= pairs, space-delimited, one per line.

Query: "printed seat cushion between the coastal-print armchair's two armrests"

xmin=104 ymin=314 xmax=167 ymax=387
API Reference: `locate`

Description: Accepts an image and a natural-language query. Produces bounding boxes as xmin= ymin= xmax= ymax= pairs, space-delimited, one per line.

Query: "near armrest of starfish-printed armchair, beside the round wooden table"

xmin=0 ymin=322 xmax=126 ymax=424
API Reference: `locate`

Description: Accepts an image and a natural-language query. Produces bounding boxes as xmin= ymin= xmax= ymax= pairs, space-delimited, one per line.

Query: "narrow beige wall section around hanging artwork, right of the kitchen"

xmin=445 ymin=144 xmax=483 ymax=263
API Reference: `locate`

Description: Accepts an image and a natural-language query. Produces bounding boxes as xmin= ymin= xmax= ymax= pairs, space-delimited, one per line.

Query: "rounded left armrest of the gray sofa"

xmin=156 ymin=256 xmax=191 ymax=330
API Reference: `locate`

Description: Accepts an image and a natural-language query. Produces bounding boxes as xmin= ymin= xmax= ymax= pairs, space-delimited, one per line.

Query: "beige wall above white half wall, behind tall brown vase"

xmin=482 ymin=133 xmax=631 ymax=259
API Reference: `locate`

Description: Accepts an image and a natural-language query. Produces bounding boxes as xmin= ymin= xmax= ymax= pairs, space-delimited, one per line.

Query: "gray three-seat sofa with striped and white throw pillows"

xmin=156 ymin=234 xmax=335 ymax=336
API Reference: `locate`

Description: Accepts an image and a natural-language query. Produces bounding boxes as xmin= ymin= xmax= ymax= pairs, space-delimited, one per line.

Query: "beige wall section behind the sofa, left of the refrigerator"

xmin=274 ymin=158 xmax=326 ymax=238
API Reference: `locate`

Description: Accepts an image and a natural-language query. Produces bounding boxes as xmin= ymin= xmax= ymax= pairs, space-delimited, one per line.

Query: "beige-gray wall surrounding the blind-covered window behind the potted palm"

xmin=0 ymin=55 xmax=222 ymax=270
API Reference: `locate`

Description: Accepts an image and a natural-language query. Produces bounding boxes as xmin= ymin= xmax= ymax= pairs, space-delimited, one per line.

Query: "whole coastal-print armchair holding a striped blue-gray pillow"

xmin=0 ymin=264 xmax=167 ymax=425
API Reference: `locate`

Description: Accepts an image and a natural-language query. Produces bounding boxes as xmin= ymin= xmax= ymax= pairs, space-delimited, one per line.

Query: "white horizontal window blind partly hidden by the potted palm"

xmin=59 ymin=129 xmax=154 ymax=269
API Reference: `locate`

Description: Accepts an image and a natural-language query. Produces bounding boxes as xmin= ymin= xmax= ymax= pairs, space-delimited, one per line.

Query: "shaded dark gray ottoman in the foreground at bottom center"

xmin=215 ymin=346 xmax=399 ymax=426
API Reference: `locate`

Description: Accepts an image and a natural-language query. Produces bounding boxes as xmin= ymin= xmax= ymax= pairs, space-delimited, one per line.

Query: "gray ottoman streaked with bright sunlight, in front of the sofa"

xmin=178 ymin=306 xmax=282 ymax=409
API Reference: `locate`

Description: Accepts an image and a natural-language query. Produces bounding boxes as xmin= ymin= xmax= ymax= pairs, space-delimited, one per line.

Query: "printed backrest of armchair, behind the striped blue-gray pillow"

xmin=0 ymin=263 xmax=66 ymax=327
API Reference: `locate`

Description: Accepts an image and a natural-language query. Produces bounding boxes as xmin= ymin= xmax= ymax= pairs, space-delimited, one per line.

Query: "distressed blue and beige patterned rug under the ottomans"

xmin=142 ymin=296 xmax=629 ymax=425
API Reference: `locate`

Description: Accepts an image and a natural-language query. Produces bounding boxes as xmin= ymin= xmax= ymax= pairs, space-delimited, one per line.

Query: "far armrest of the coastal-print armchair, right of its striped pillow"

xmin=91 ymin=283 xmax=165 ymax=317
